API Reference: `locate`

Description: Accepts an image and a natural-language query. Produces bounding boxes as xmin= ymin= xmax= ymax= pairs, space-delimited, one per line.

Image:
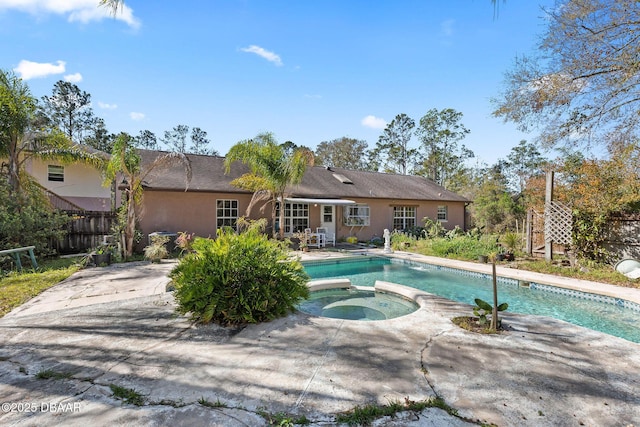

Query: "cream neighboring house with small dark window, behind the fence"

xmin=25 ymin=146 xmax=113 ymax=211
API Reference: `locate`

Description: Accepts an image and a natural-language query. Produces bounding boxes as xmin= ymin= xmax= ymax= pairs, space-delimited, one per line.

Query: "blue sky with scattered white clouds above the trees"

xmin=0 ymin=0 xmax=553 ymax=164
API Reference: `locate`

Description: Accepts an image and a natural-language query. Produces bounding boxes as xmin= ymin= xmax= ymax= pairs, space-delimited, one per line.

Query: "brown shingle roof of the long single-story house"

xmin=140 ymin=150 xmax=469 ymax=202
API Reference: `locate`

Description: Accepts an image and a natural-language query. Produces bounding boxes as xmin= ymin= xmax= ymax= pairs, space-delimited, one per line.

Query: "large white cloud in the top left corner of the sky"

xmin=0 ymin=0 xmax=140 ymax=28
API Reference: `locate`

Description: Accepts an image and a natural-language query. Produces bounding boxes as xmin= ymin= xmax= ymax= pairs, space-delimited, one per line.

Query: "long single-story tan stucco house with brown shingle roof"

xmin=140 ymin=150 xmax=470 ymax=244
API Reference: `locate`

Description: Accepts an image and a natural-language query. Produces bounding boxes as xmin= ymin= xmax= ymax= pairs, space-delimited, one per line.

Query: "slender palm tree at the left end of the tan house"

xmin=105 ymin=133 xmax=191 ymax=258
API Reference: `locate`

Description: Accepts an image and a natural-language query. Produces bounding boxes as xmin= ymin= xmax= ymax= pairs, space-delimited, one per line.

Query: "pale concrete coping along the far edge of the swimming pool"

xmin=301 ymin=248 xmax=640 ymax=307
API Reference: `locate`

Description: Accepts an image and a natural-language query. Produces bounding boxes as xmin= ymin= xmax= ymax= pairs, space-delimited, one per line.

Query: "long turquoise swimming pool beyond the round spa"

xmin=303 ymin=257 xmax=640 ymax=343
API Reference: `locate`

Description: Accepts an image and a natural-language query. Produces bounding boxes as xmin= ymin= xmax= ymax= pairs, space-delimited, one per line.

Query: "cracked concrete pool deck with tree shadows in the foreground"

xmin=0 ymin=251 xmax=640 ymax=427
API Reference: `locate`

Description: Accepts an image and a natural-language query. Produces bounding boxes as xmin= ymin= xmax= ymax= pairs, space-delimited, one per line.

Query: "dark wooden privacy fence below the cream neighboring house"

xmin=54 ymin=211 xmax=117 ymax=254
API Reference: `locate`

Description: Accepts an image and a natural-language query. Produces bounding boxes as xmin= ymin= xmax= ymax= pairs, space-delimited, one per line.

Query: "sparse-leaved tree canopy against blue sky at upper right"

xmin=492 ymin=0 xmax=640 ymax=151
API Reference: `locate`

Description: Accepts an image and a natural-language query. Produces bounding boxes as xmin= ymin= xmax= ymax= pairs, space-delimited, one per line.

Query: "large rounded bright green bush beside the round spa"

xmin=170 ymin=222 xmax=309 ymax=326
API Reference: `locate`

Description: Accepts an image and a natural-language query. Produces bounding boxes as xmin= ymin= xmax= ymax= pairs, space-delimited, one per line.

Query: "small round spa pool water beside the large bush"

xmin=298 ymin=289 xmax=419 ymax=320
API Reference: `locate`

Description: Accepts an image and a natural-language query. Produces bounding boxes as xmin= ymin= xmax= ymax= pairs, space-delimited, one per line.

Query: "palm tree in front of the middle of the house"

xmin=224 ymin=133 xmax=314 ymax=239
